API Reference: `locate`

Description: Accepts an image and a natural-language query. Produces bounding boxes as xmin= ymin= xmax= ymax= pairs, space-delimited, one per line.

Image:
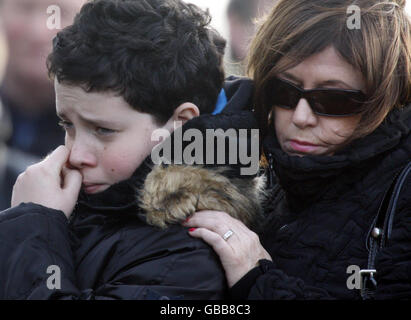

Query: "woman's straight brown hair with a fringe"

xmin=248 ymin=0 xmax=411 ymax=138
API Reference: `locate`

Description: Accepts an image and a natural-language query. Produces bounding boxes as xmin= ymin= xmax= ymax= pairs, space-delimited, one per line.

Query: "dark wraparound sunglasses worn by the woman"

xmin=265 ymin=78 xmax=365 ymax=117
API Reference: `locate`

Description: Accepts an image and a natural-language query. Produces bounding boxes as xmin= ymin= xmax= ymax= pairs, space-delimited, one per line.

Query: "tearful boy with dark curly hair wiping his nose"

xmin=0 ymin=0 xmax=264 ymax=299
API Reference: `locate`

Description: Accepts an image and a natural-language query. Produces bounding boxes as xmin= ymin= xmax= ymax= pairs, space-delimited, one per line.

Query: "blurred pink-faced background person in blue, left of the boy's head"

xmin=0 ymin=0 xmax=85 ymax=162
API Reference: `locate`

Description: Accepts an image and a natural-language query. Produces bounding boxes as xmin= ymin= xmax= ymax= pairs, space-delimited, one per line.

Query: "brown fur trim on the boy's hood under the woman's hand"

xmin=140 ymin=165 xmax=265 ymax=228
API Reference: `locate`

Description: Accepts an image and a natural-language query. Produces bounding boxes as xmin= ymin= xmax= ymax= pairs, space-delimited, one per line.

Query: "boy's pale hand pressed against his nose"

xmin=11 ymin=146 xmax=82 ymax=218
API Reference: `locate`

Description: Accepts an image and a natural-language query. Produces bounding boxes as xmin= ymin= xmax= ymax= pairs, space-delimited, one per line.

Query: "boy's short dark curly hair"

xmin=47 ymin=0 xmax=229 ymax=123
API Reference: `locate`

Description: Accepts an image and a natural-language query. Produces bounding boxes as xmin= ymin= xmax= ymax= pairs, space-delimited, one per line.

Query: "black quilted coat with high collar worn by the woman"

xmin=231 ymin=81 xmax=411 ymax=299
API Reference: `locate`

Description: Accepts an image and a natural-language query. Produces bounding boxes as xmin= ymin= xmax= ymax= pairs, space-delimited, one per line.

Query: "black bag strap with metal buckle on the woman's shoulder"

xmin=360 ymin=162 xmax=411 ymax=300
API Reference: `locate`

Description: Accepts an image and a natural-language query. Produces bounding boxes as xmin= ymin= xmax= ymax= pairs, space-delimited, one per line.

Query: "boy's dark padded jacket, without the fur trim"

xmin=0 ymin=79 xmax=255 ymax=300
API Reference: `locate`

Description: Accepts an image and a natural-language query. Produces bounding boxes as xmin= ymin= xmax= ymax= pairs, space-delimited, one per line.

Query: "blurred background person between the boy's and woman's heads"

xmin=226 ymin=0 xmax=277 ymax=76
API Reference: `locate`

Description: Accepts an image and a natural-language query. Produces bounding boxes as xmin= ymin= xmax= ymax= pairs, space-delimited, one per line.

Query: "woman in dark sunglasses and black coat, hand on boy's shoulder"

xmin=185 ymin=0 xmax=411 ymax=299
